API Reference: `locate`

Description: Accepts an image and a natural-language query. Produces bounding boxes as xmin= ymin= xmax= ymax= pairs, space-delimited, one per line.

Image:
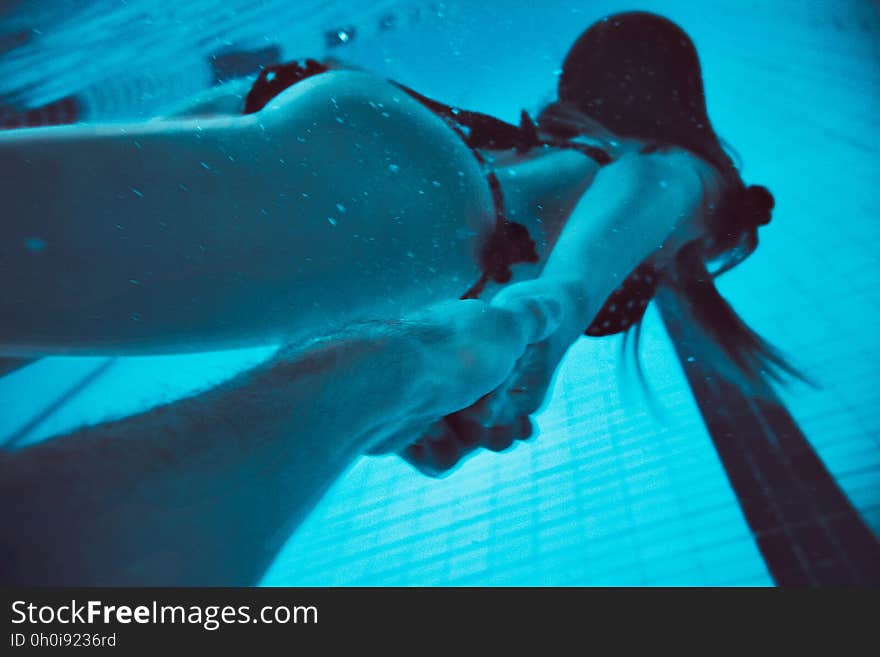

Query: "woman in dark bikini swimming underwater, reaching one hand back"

xmin=0 ymin=12 xmax=790 ymax=472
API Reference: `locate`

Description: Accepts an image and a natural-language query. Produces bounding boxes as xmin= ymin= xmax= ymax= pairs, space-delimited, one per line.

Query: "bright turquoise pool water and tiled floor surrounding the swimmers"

xmin=0 ymin=0 xmax=880 ymax=585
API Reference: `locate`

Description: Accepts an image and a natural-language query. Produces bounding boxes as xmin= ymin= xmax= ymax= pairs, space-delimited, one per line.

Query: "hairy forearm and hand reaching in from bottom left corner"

xmin=0 ymin=292 xmax=561 ymax=585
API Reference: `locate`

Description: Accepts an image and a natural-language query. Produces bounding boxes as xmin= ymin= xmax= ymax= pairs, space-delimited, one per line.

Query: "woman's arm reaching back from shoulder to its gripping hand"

xmin=401 ymin=151 xmax=712 ymax=475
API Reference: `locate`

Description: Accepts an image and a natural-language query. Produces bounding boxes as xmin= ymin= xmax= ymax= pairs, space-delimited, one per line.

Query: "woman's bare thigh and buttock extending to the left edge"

xmin=0 ymin=71 xmax=494 ymax=357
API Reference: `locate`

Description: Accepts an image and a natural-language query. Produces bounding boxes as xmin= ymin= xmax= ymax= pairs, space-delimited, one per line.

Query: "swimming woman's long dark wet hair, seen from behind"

xmin=539 ymin=12 xmax=806 ymax=381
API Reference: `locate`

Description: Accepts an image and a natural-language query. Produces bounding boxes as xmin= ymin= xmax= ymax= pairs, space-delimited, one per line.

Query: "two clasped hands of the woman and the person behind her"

xmin=368 ymin=279 xmax=583 ymax=477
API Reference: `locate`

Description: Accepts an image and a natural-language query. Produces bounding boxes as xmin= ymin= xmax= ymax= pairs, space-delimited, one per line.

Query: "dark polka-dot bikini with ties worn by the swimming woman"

xmin=243 ymin=59 xmax=659 ymax=336
